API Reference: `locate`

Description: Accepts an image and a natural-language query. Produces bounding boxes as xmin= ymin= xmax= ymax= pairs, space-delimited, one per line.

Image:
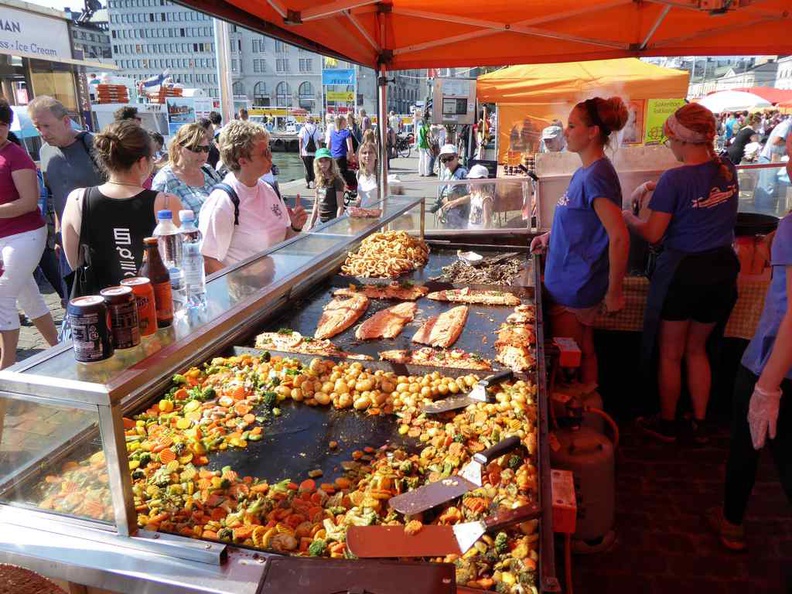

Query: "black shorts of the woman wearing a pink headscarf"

xmin=661 ymin=248 xmax=740 ymax=324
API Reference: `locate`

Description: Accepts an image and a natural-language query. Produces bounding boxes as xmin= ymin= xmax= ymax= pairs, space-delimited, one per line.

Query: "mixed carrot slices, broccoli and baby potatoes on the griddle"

xmin=40 ymin=355 xmax=539 ymax=592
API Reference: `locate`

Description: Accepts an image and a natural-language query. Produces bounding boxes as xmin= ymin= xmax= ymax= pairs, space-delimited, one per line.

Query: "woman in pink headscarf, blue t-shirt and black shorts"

xmin=624 ymin=104 xmax=739 ymax=443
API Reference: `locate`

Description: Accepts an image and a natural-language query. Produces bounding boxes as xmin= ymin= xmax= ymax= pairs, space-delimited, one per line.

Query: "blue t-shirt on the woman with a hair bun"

xmin=545 ymin=158 xmax=622 ymax=307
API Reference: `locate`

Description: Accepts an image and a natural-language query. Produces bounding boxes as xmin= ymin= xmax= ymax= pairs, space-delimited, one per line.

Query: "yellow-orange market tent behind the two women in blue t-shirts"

xmin=476 ymin=58 xmax=689 ymax=165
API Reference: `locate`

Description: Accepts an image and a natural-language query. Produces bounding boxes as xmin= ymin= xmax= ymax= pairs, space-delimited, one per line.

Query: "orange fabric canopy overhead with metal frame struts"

xmin=179 ymin=0 xmax=792 ymax=70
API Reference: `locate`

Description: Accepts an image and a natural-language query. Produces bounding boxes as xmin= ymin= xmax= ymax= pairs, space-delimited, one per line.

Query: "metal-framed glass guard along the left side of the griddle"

xmin=0 ymin=197 xmax=423 ymax=535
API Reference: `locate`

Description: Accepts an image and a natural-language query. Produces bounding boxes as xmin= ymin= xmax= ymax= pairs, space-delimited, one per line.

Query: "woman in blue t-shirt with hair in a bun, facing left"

xmin=531 ymin=97 xmax=630 ymax=383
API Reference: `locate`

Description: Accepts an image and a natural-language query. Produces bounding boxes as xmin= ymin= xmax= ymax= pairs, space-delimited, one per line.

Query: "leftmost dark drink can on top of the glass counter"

xmin=66 ymin=295 xmax=113 ymax=363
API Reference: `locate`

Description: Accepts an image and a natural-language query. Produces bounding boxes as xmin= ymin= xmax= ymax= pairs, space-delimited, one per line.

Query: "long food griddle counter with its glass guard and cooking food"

xmin=0 ymin=198 xmax=554 ymax=593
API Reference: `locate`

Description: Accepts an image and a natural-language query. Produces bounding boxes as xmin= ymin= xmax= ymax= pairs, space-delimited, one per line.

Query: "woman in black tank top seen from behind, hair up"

xmin=62 ymin=121 xmax=184 ymax=287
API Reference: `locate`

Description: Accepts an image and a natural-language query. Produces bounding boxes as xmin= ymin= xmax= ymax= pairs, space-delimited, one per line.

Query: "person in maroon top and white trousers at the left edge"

xmin=0 ymin=98 xmax=58 ymax=369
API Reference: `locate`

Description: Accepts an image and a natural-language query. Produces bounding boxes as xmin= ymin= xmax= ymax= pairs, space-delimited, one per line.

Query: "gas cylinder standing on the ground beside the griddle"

xmin=549 ymin=426 xmax=615 ymax=552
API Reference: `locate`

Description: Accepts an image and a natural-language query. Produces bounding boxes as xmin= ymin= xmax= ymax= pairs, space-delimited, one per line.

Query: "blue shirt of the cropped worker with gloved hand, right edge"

xmin=742 ymin=214 xmax=792 ymax=379
